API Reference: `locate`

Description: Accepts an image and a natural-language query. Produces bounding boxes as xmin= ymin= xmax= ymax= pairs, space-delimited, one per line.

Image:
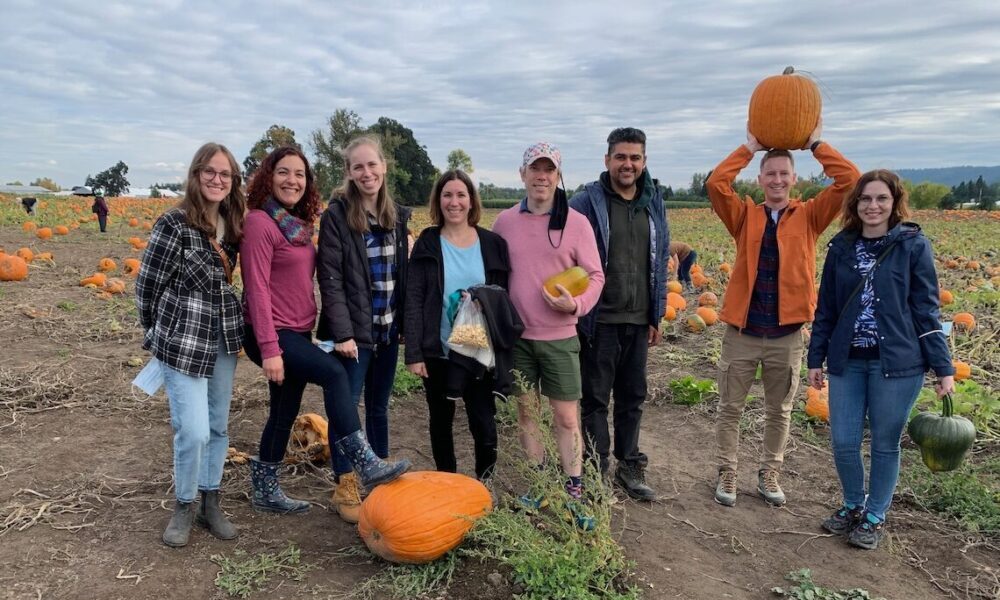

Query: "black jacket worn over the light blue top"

xmin=403 ymin=227 xmax=510 ymax=365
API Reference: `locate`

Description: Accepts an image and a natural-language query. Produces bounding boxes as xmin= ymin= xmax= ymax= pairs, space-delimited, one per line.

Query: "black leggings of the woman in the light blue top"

xmin=424 ymin=358 xmax=497 ymax=479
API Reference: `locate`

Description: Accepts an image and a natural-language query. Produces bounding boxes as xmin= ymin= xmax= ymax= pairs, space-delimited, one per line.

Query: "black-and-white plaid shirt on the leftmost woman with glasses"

xmin=135 ymin=208 xmax=243 ymax=377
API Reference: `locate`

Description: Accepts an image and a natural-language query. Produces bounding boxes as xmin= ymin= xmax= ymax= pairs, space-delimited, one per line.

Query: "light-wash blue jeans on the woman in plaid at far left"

xmin=163 ymin=338 xmax=236 ymax=502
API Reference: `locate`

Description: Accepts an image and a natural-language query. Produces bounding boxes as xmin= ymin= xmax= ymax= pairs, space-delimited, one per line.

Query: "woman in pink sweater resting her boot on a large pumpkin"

xmin=240 ymin=146 xmax=410 ymax=513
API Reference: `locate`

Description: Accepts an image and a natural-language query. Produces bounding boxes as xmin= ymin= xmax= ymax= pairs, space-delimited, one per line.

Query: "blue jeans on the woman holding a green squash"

xmin=830 ymin=359 xmax=924 ymax=520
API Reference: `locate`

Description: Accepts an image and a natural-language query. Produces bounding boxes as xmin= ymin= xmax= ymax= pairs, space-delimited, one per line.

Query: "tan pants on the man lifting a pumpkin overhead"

xmin=715 ymin=325 xmax=803 ymax=471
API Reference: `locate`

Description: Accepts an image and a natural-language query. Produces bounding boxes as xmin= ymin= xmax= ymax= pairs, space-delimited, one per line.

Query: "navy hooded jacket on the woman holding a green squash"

xmin=808 ymin=223 xmax=955 ymax=377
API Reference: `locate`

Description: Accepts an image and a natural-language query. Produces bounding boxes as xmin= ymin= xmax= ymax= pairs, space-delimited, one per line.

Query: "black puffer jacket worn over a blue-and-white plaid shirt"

xmin=316 ymin=198 xmax=410 ymax=348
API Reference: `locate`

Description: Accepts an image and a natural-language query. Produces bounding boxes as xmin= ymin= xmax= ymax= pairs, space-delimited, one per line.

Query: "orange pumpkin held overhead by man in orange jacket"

xmin=747 ymin=67 xmax=823 ymax=150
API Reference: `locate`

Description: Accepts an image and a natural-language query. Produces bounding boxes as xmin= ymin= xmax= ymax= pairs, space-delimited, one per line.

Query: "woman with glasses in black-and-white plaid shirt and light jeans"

xmin=135 ymin=143 xmax=246 ymax=547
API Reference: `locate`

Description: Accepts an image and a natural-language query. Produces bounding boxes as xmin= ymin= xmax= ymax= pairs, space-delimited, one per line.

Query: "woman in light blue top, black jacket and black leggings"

xmin=404 ymin=170 xmax=510 ymax=479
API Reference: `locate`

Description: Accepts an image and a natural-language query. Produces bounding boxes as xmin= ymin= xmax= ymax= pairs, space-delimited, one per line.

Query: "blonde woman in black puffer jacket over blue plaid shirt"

xmin=316 ymin=137 xmax=410 ymax=523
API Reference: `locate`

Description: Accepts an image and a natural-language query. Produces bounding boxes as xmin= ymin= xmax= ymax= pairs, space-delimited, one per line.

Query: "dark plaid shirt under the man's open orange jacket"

xmin=743 ymin=206 xmax=802 ymax=338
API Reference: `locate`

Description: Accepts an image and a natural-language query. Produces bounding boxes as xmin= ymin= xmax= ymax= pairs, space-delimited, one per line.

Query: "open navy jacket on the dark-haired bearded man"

xmin=569 ymin=171 xmax=670 ymax=337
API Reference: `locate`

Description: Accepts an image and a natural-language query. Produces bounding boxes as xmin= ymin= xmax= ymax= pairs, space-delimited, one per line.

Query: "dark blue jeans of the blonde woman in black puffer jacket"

xmin=331 ymin=335 xmax=399 ymax=475
